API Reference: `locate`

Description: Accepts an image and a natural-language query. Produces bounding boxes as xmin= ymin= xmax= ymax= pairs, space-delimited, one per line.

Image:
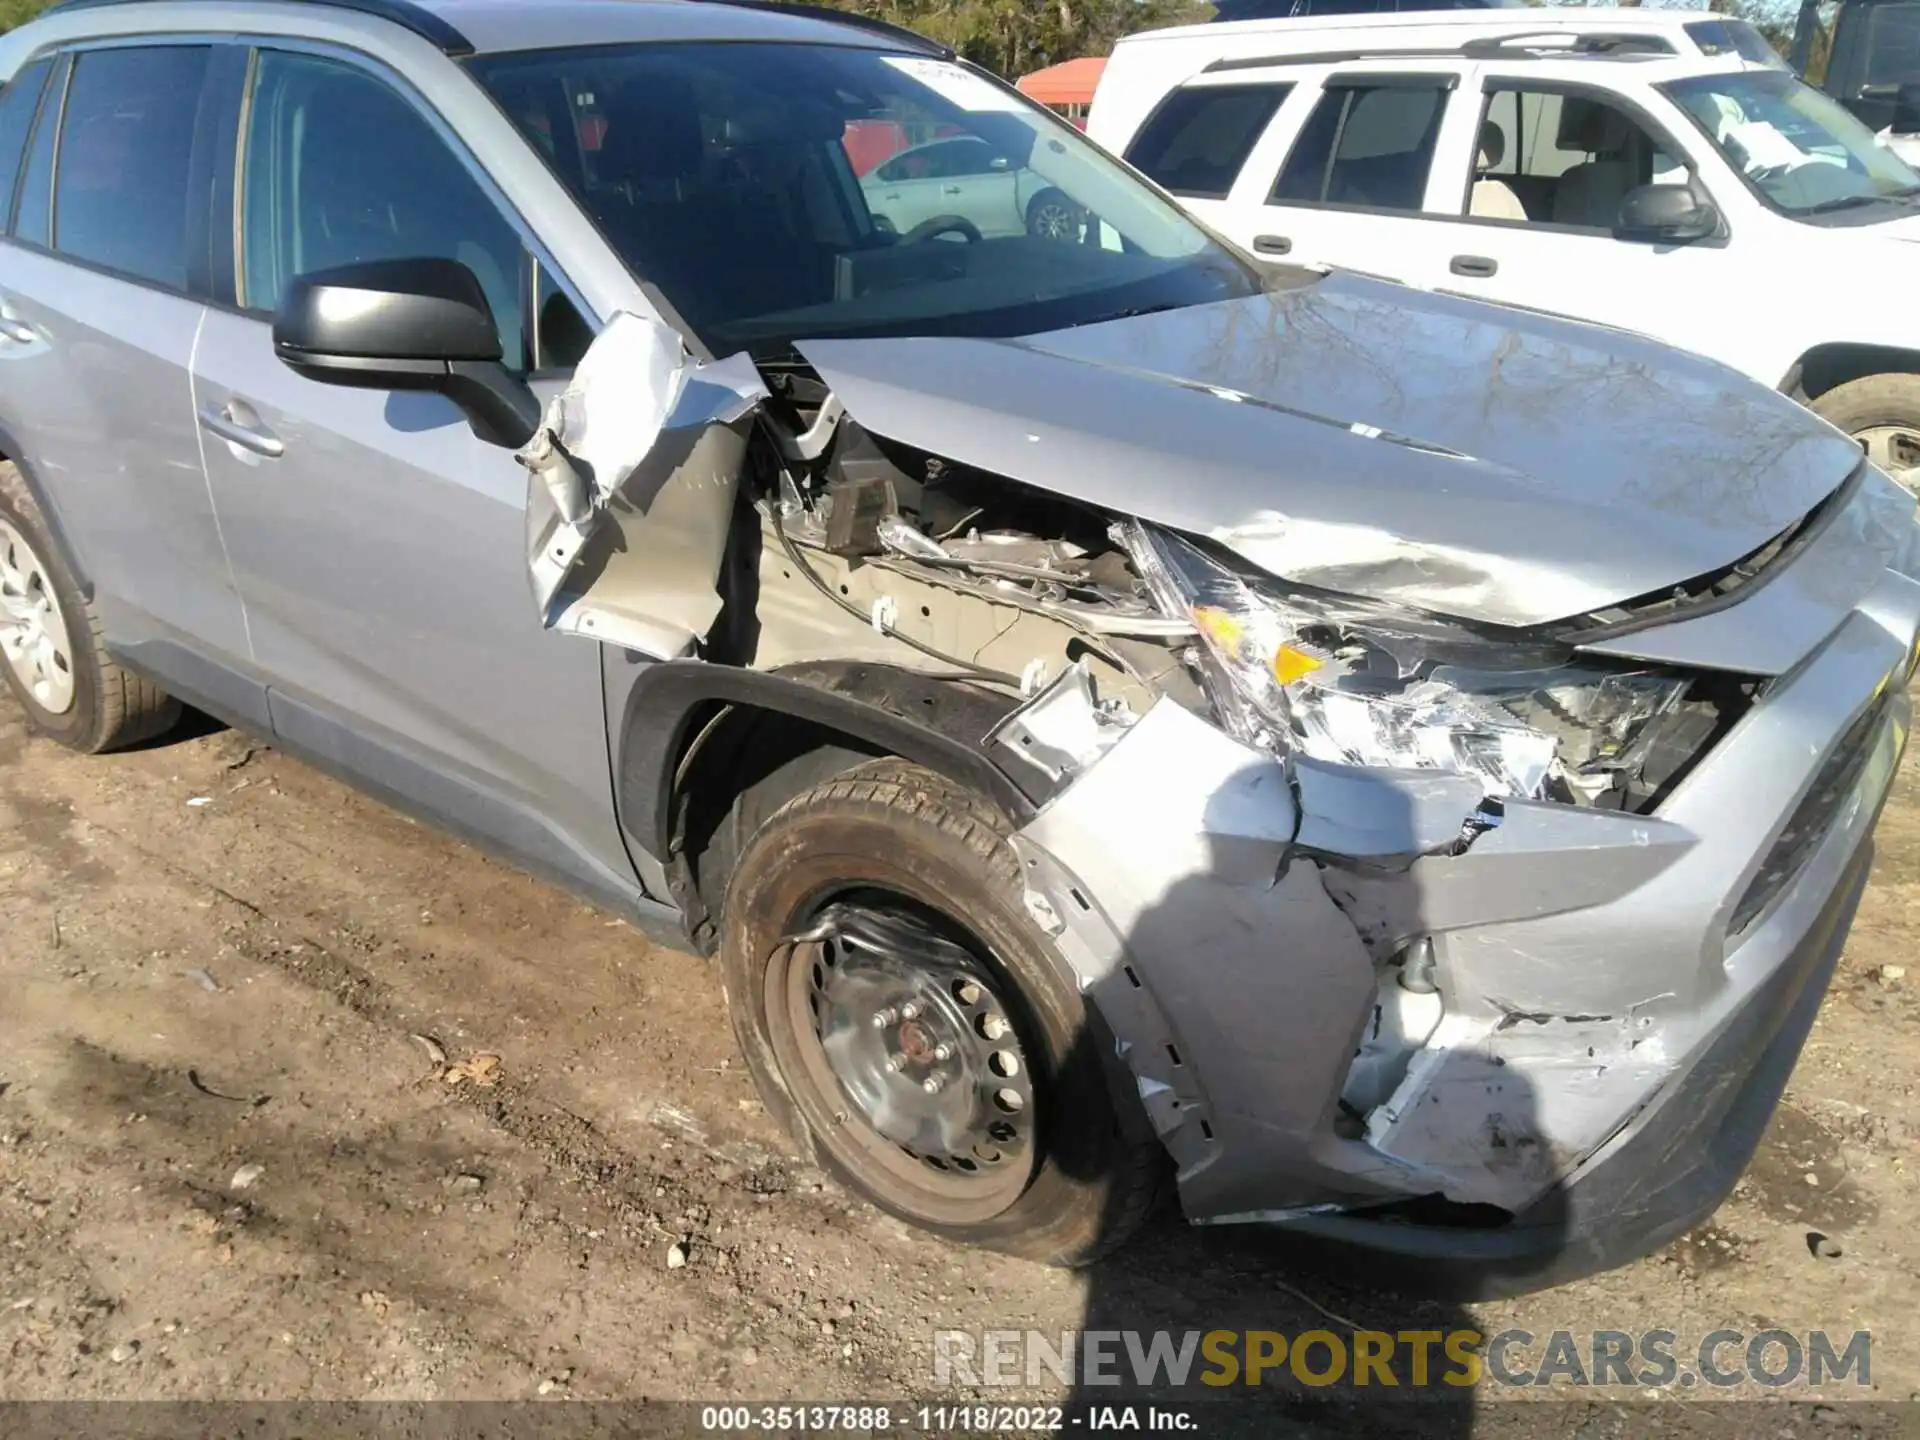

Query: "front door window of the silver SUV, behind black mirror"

xmin=240 ymin=50 xmax=532 ymax=369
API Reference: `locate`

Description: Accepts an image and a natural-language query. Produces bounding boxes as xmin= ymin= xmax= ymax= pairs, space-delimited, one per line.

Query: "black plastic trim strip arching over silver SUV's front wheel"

xmin=614 ymin=660 xmax=1035 ymax=864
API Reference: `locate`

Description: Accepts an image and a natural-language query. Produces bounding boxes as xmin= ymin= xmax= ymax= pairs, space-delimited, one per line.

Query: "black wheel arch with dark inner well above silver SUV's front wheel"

xmin=614 ymin=660 xmax=1035 ymax=948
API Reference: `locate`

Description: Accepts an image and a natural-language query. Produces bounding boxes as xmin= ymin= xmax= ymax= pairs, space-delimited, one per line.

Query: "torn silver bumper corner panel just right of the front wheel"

xmin=1014 ymin=701 xmax=1413 ymax=1219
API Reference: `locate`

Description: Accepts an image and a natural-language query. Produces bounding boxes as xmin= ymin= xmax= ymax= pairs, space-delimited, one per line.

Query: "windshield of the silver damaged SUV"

xmin=470 ymin=42 xmax=1258 ymax=353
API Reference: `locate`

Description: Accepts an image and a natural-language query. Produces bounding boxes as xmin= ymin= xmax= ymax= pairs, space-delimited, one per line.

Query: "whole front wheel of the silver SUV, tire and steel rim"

xmin=720 ymin=758 xmax=1165 ymax=1265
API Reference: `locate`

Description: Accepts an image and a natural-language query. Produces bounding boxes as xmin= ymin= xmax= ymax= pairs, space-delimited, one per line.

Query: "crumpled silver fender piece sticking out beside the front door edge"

xmin=518 ymin=311 xmax=766 ymax=657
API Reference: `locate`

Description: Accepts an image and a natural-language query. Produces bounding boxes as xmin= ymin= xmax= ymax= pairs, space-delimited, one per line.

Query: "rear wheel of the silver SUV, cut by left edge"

xmin=0 ymin=461 xmax=180 ymax=755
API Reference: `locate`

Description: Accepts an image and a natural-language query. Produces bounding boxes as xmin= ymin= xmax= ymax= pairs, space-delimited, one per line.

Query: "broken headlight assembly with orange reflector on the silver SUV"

xmin=1125 ymin=522 xmax=1688 ymax=806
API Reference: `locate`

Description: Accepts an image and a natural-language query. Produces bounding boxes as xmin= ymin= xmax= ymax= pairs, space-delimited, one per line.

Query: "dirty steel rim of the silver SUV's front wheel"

xmin=766 ymin=889 xmax=1041 ymax=1225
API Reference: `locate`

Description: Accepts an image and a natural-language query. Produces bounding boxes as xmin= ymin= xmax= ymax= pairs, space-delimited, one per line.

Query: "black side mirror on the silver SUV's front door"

xmin=273 ymin=259 xmax=540 ymax=449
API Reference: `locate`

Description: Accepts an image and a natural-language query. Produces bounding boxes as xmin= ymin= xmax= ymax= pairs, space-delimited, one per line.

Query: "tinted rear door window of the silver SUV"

xmin=54 ymin=46 xmax=213 ymax=290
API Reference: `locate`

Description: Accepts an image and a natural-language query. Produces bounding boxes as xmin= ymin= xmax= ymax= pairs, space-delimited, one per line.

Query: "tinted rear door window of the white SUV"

xmin=1273 ymin=77 xmax=1450 ymax=209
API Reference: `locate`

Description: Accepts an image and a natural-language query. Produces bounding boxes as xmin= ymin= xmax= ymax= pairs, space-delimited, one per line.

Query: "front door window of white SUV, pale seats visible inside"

xmin=1463 ymin=86 xmax=1686 ymax=232
